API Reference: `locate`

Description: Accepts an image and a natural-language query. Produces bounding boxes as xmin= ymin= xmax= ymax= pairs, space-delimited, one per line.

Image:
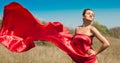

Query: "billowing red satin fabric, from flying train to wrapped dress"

xmin=0 ymin=2 xmax=96 ymax=63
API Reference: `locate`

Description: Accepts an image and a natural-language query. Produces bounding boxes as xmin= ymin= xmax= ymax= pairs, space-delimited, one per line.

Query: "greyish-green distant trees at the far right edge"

xmin=109 ymin=27 xmax=120 ymax=38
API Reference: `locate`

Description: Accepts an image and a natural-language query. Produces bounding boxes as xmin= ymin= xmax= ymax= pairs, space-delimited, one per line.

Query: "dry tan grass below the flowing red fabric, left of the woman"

xmin=0 ymin=46 xmax=72 ymax=63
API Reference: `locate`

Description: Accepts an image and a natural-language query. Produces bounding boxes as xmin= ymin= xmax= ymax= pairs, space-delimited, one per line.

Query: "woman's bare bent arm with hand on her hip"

xmin=89 ymin=26 xmax=110 ymax=55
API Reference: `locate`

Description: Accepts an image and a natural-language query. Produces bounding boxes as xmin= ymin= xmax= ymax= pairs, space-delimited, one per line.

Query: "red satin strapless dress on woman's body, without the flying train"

xmin=69 ymin=34 xmax=96 ymax=63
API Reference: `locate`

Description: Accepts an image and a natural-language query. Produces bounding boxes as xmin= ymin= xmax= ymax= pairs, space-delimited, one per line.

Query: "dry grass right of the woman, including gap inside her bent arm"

xmin=93 ymin=37 xmax=120 ymax=63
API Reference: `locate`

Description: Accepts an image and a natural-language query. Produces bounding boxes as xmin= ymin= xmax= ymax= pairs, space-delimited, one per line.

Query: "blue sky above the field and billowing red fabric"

xmin=0 ymin=0 xmax=120 ymax=28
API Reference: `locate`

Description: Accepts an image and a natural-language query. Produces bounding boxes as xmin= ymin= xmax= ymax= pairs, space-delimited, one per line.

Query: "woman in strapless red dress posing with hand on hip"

xmin=73 ymin=9 xmax=109 ymax=63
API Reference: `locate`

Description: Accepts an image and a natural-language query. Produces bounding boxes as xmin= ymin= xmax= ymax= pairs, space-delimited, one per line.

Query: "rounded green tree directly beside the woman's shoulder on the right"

xmin=92 ymin=21 xmax=109 ymax=35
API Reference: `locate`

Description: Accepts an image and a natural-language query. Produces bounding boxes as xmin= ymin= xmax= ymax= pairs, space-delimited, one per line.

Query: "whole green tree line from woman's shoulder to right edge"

xmin=93 ymin=21 xmax=120 ymax=38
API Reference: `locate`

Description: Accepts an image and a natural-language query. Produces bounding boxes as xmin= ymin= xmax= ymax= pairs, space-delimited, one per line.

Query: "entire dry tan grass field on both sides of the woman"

xmin=0 ymin=37 xmax=120 ymax=63
